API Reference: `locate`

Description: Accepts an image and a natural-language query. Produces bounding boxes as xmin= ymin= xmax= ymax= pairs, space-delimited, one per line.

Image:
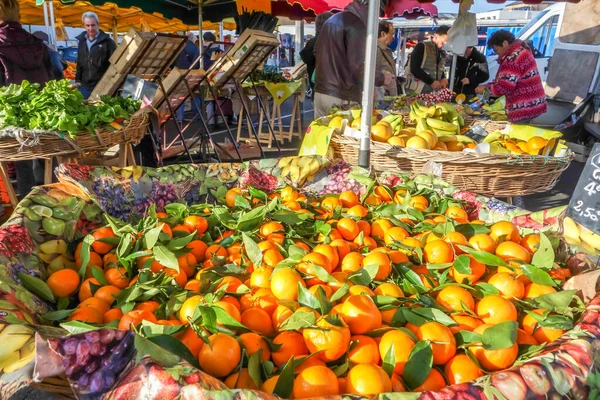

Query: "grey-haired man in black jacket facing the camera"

xmin=75 ymin=12 xmax=117 ymax=99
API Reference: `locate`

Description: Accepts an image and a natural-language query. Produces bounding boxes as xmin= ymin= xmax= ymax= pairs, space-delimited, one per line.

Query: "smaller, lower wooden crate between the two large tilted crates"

xmin=152 ymin=67 xmax=206 ymax=115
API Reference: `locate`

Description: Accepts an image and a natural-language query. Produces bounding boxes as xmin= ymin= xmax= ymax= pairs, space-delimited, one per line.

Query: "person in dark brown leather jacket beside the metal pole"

xmin=314 ymin=0 xmax=392 ymax=118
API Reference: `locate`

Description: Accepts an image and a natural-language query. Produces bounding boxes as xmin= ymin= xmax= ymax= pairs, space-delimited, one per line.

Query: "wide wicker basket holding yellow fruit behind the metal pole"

xmin=331 ymin=135 xmax=572 ymax=197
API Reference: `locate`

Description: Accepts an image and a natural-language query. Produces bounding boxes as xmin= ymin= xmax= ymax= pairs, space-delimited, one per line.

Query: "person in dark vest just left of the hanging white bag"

xmin=405 ymin=25 xmax=450 ymax=94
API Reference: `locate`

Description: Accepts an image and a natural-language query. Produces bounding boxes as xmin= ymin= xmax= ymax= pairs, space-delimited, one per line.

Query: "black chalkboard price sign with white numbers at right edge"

xmin=567 ymin=143 xmax=600 ymax=234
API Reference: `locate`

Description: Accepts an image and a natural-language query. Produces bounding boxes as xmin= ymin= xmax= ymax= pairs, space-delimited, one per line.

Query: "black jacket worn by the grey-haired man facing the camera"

xmin=75 ymin=30 xmax=117 ymax=88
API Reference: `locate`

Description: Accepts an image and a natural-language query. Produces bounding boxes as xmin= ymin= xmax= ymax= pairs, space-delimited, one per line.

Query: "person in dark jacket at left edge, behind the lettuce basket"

xmin=0 ymin=0 xmax=52 ymax=197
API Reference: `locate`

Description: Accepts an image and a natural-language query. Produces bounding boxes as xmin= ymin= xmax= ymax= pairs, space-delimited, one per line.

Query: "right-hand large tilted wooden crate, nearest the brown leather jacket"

xmin=206 ymin=29 xmax=279 ymax=88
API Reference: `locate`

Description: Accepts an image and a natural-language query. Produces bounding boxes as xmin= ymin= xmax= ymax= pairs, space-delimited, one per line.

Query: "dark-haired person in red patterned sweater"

xmin=475 ymin=30 xmax=547 ymax=124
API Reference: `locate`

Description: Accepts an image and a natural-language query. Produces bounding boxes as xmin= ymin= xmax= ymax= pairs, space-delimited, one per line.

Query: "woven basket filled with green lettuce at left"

xmin=0 ymin=109 xmax=150 ymax=161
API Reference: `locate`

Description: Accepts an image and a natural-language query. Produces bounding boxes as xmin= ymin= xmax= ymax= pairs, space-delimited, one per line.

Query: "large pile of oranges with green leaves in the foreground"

xmin=47 ymin=186 xmax=570 ymax=399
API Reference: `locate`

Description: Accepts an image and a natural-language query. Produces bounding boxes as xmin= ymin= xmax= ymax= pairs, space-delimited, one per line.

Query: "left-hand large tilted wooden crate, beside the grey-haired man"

xmin=90 ymin=28 xmax=187 ymax=100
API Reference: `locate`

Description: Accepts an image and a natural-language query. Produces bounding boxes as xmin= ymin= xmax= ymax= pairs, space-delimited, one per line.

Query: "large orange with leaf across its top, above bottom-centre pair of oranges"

xmin=302 ymin=318 xmax=350 ymax=363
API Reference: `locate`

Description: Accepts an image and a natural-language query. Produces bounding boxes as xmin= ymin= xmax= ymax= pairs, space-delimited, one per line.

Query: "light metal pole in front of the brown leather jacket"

xmin=358 ymin=0 xmax=379 ymax=168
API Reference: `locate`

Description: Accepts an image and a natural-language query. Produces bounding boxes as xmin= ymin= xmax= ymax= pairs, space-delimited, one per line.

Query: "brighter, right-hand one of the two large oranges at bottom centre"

xmin=346 ymin=364 xmax=392 ymax=396
